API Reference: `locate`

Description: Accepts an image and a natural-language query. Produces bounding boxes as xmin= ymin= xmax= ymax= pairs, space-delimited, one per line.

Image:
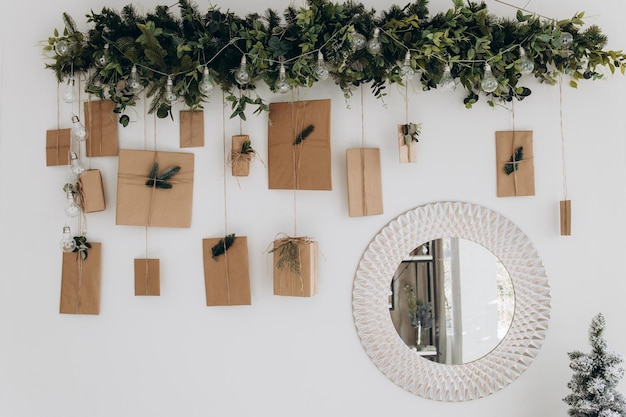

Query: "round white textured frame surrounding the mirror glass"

xmin=352 ymin=202 xmax=550 ymax=401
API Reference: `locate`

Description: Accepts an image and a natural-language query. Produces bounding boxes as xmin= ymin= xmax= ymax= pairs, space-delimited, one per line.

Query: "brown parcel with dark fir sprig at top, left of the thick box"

xmin=202 ymin=236 xmax=252 ymax=306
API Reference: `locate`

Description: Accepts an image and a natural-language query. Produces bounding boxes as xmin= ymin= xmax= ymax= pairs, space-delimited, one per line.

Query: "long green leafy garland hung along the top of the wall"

xmin=44 ymin=0 xmax=626 ymax=124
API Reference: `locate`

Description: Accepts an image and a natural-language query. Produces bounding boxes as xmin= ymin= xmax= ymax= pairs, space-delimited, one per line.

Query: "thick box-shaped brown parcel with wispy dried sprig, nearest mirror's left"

xmin=273 ymin=238 xmax=318 ymax=297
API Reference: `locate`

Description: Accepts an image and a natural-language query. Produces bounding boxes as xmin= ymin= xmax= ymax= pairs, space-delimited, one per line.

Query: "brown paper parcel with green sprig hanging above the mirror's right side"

xmin=496 ymin=130 xmax=535 ymax=197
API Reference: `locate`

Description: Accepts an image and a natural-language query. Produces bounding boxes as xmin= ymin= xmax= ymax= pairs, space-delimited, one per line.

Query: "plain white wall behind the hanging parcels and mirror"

xmin=0 ymin=0 xmax=626 ymax=417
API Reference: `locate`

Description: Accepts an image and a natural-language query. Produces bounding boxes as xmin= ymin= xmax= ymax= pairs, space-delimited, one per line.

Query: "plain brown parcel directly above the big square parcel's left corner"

xmin=85 ymin=100 xmax=118 ymax=157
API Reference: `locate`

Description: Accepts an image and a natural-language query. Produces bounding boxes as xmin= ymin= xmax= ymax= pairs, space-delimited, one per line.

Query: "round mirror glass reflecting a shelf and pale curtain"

xmin=389 ymin=237 xmax=515 ymax=365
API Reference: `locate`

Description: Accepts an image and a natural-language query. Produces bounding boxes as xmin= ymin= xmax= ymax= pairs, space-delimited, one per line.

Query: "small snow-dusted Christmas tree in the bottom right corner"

xmin=563 ymin=314 xmax=626 ymax=417
